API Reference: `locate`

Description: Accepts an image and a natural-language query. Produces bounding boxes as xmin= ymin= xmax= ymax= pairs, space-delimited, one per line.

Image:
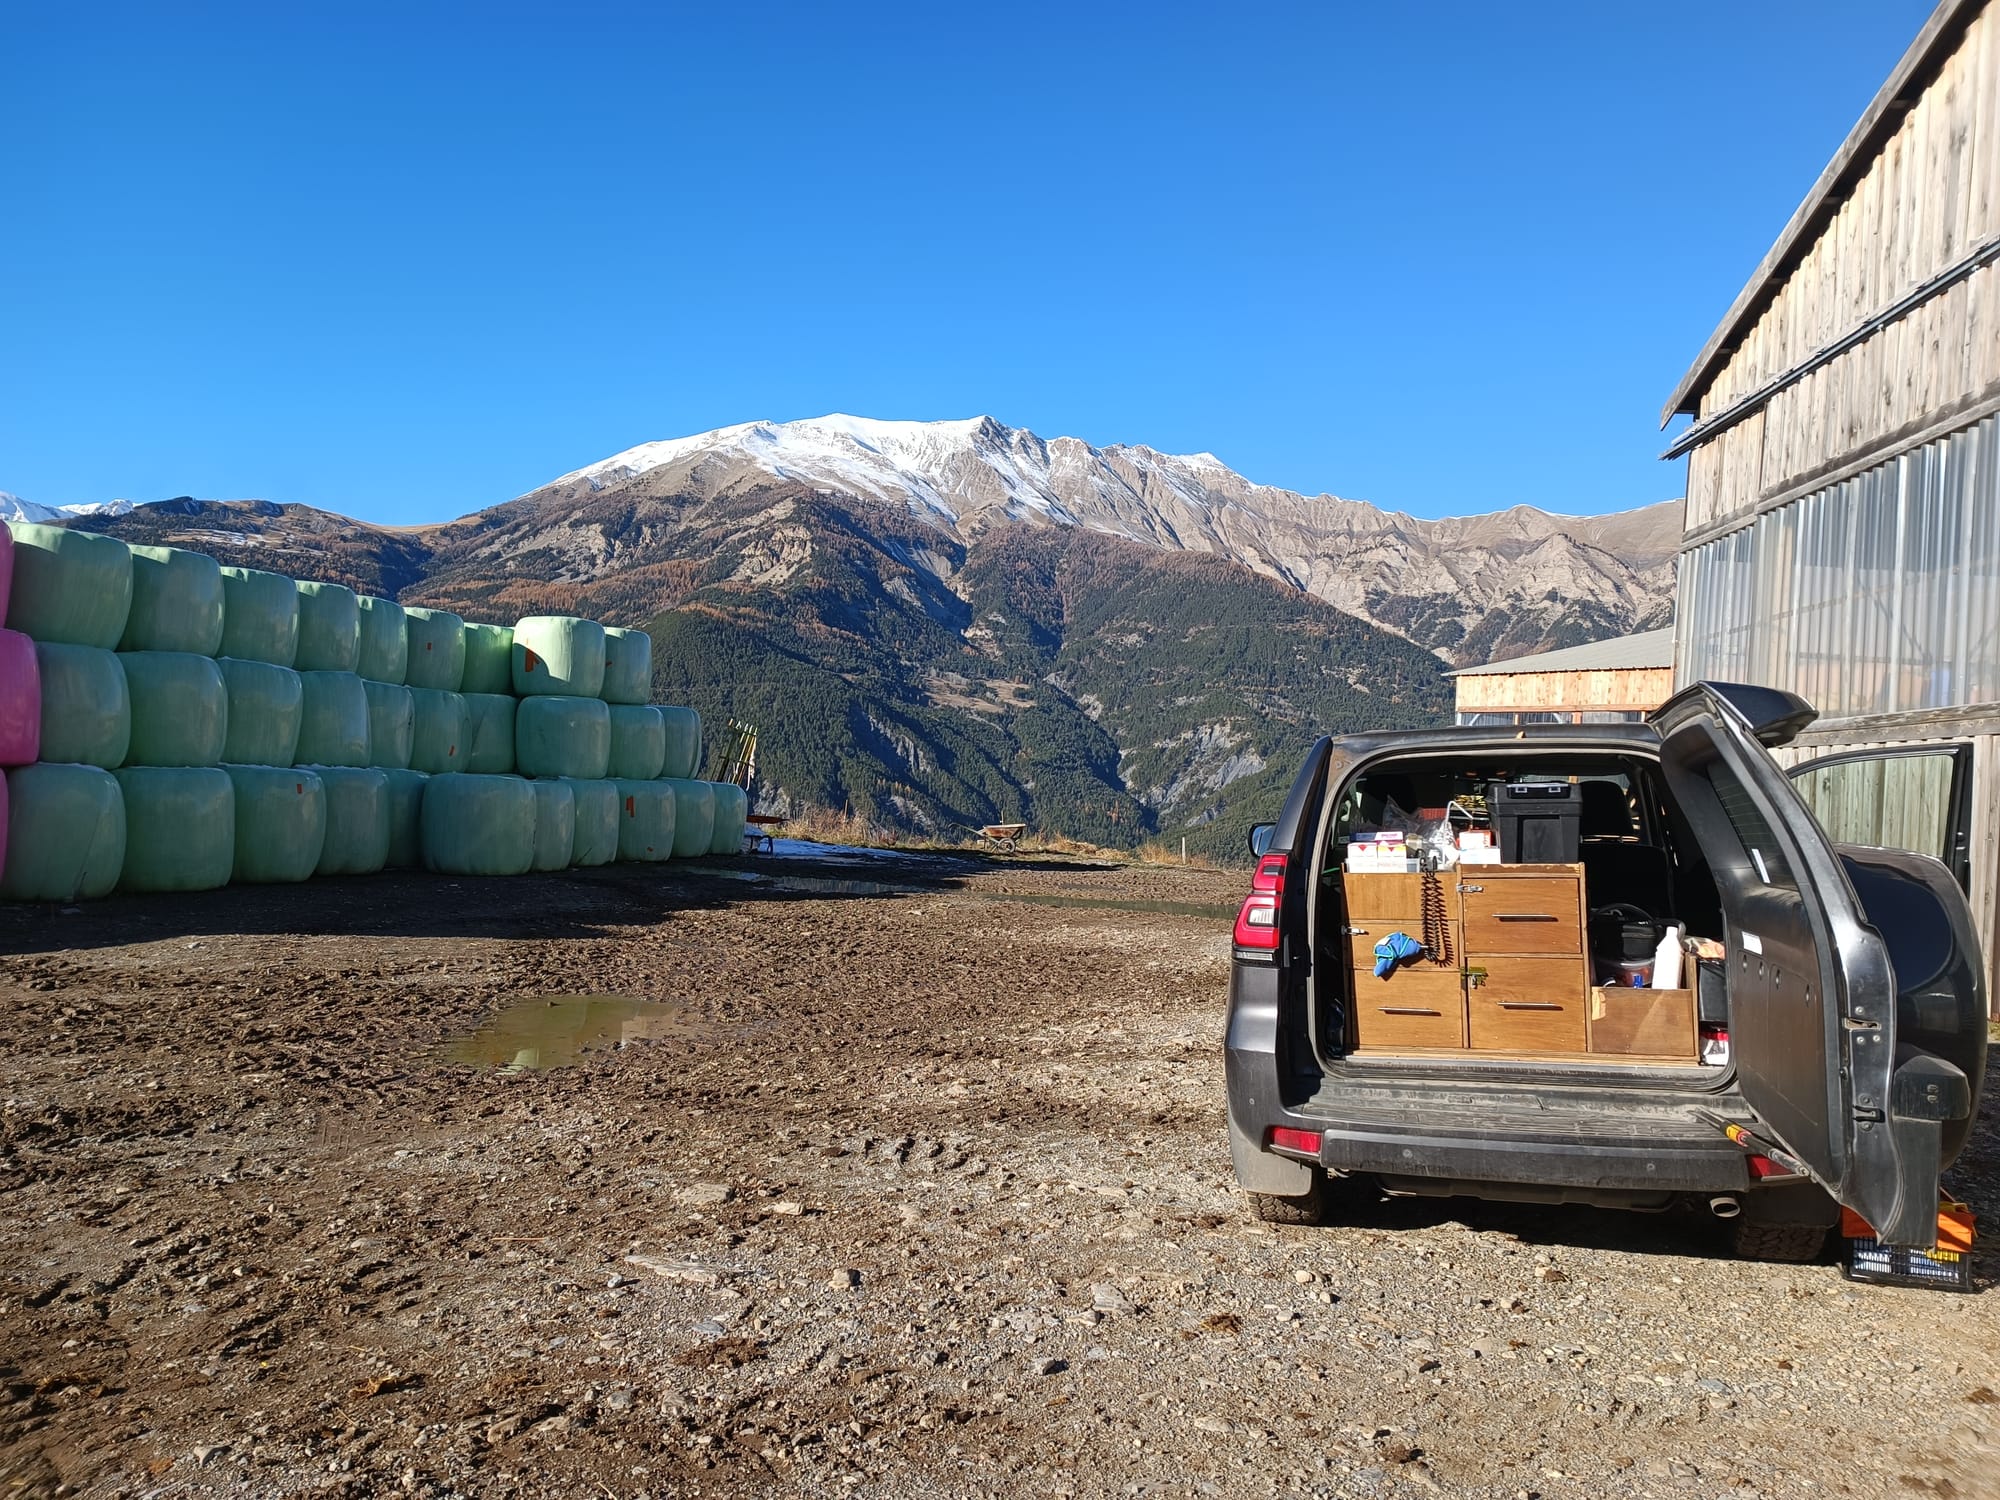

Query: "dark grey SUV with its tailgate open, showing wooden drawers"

xmin=1226 ymin=684 xmax=1986 ymax=1260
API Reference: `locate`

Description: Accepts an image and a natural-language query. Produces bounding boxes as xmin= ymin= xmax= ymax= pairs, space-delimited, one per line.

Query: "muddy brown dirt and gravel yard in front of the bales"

xmin=0 ymin=858 xmax=2000 ymax=1500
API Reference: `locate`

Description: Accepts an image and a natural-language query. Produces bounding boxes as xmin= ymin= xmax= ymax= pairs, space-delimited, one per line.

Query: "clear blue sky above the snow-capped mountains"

xmin=0 ymin=0 xmax=1930 ymax=524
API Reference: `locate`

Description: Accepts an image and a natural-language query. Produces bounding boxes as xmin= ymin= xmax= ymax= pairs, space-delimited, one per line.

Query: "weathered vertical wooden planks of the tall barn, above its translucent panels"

xmin=1686 ymin=4 xmax=2000 ymax=532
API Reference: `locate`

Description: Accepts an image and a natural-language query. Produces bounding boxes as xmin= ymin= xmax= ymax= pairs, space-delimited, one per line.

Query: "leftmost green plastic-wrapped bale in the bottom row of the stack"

xmin=0 ymin=764 xmax=124 ymax=902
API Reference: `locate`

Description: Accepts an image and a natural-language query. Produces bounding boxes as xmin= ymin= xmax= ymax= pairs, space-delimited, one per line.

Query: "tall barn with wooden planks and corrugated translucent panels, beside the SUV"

xmin=1662 ymin=0 xmax=2000 ymax=1016
